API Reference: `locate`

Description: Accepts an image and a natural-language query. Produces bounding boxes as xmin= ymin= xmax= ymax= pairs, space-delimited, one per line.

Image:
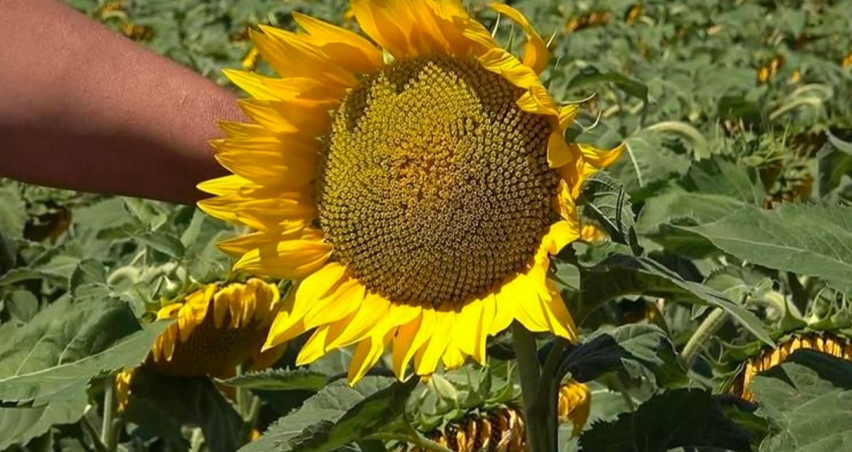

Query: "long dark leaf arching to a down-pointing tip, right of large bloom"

xmin=576 ymin=254 xmax=774 ymax=345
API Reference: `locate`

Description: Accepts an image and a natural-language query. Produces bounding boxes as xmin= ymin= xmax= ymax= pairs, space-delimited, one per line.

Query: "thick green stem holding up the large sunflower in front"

xmin=512 ymin=322 xmax=558 ymax=452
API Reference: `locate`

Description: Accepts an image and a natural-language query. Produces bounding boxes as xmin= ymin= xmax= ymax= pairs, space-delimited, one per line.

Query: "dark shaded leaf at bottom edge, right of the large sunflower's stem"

xmin=580 ymin=389 xmax=751 ymax=452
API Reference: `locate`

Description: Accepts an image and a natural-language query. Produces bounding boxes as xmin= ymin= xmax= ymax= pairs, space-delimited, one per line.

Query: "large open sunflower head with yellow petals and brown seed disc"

xmin=199 ymin=0 xmax=621 ymax=382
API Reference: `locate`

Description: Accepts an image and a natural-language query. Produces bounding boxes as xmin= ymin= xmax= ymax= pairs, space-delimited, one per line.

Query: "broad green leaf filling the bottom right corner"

xmin=750 ymin=350 xmax=852 ymax=452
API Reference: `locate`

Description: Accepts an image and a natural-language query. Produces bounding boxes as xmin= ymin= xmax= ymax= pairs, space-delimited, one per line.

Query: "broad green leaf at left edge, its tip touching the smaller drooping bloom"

xmin=0 ymin=299 xmax=168 ymax=406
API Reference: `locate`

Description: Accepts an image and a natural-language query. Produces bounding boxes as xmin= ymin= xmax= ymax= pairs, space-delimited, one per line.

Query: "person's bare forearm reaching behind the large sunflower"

xmin=0 ymin=0 xmax=245 ymax=204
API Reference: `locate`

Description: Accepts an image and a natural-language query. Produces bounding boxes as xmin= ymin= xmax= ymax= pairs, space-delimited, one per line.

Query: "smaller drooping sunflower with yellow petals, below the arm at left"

xmin=147 ymin=279 xmax=284 ymax=378
